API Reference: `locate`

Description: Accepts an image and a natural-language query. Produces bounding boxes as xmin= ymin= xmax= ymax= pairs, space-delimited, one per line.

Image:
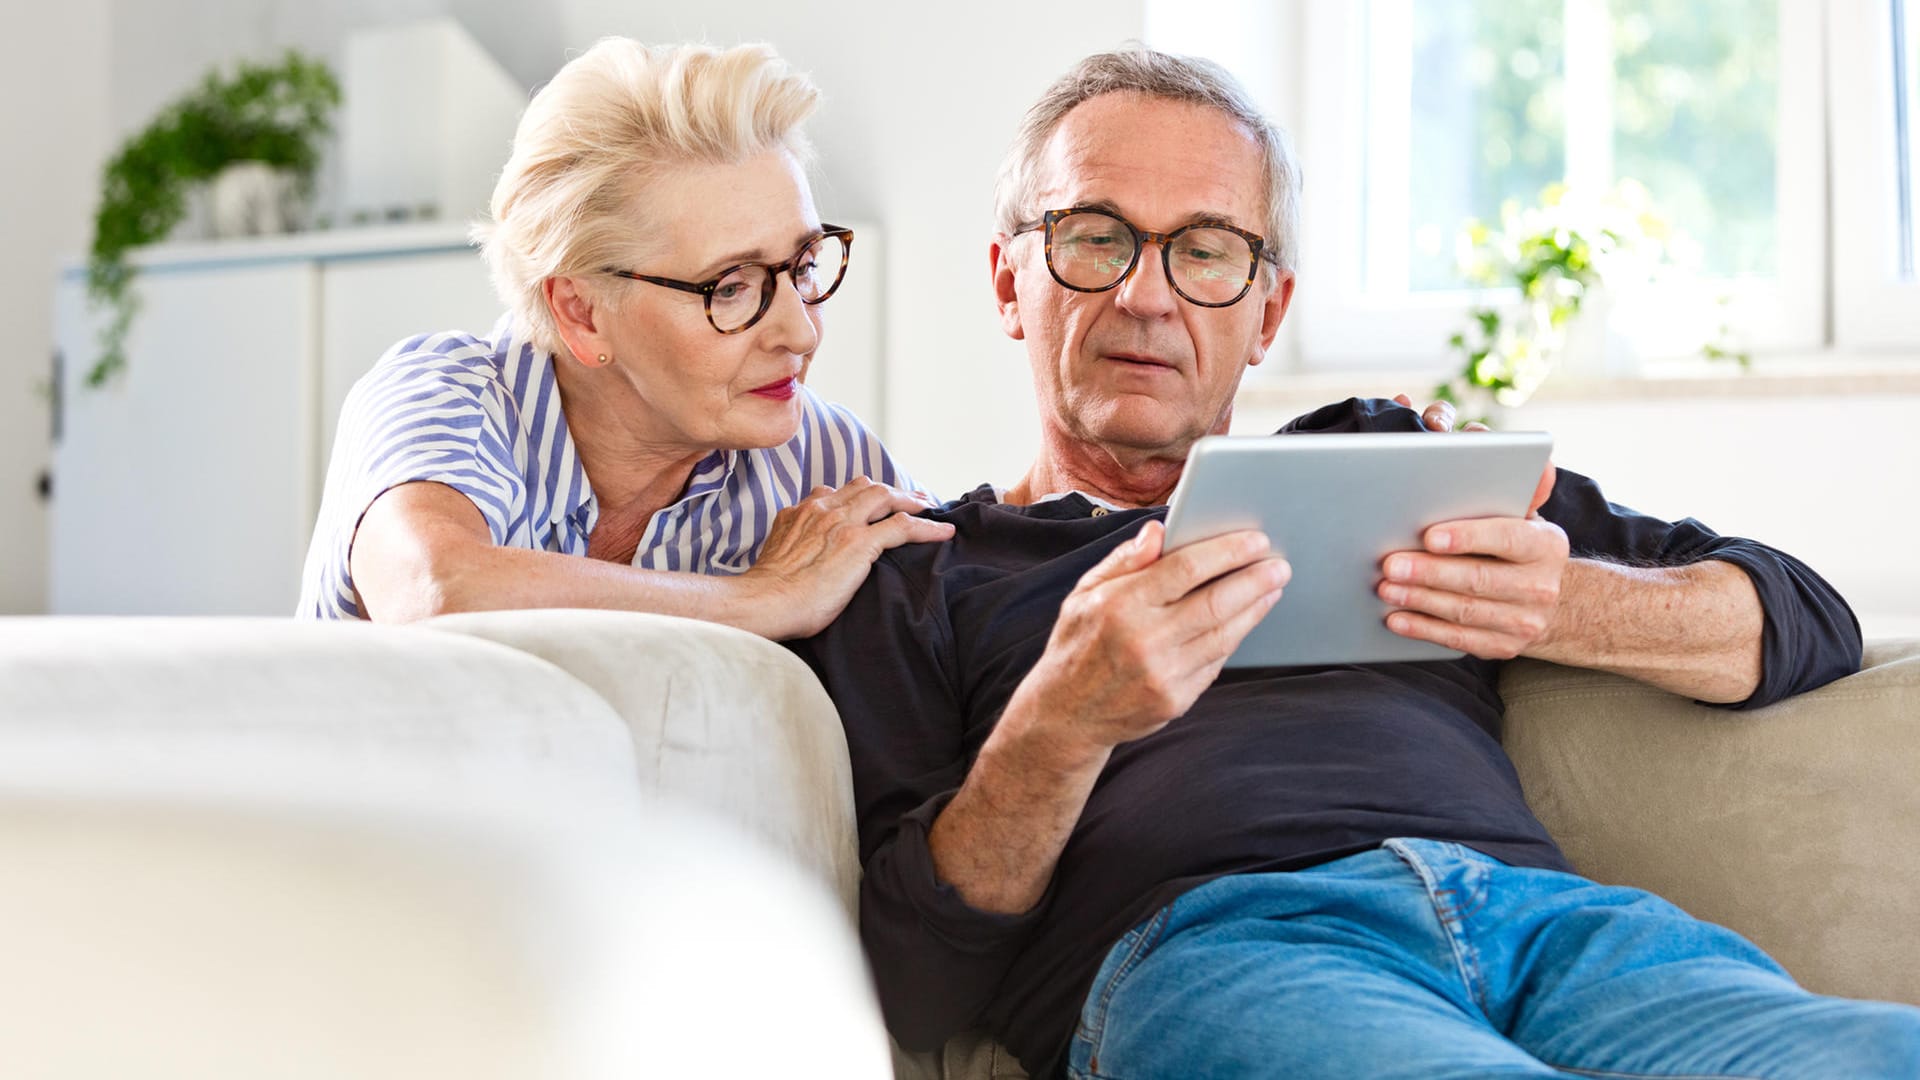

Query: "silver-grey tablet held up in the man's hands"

xmin=1165 ymin=432 xmax=1553 ymax=667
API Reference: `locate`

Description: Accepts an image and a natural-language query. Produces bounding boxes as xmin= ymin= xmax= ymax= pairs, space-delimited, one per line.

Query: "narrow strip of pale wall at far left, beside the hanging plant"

xmin=0 ymin=0 xmax=110 ymax=613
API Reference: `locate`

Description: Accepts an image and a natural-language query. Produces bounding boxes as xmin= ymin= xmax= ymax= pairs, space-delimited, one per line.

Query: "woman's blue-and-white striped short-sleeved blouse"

xmin=298 ymin=317 xmax=914 ymax=619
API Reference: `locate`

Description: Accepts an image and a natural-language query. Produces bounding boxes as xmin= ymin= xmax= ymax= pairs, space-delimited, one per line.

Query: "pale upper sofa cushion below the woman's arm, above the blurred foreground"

xmin=0 ymin=617 xmax=636 ymax=799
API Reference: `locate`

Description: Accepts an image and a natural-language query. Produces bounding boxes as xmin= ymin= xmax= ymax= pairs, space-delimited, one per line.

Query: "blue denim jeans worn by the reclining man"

xmin=1068 ymin=840 xmax=1920 ymax=1080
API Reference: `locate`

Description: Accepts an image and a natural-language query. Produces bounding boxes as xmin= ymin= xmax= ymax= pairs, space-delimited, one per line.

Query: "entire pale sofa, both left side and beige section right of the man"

xmin=0 ymin=611 xmax=1920 ymax=1078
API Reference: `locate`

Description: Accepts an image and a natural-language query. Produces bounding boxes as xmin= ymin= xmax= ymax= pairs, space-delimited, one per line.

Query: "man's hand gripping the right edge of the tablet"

xmin=1379 ymin=461 xmax=1567 ymax=659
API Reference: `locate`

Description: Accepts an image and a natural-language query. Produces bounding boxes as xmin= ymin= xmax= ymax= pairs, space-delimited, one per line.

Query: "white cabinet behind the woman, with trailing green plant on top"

xmin=48 ymin=225 xmax=497 ymax=615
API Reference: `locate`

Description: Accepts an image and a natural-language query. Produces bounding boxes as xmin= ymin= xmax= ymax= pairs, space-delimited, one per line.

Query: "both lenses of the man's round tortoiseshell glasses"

xmin=1048 ymin=209 xmax=1254 ymax=304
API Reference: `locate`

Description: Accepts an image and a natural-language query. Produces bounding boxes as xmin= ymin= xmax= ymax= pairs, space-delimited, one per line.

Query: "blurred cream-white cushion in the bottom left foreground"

xmin=0 ymin=788 xmax=889 ymax=1080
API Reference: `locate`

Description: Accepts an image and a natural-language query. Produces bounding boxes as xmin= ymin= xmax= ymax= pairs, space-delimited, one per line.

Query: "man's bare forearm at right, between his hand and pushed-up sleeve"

xmin=1526 ymin=559 xmax=1764 ymax=701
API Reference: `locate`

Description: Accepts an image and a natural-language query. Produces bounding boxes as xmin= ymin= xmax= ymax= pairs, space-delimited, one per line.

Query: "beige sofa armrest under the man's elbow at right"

xmin=1501 ymin=640 xmax=1920 ymax=1003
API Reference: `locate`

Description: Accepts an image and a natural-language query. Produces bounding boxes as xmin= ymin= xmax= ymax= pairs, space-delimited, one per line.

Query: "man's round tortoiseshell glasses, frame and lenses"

xmin=1014 ymin=206 xmax=1273 ymax=307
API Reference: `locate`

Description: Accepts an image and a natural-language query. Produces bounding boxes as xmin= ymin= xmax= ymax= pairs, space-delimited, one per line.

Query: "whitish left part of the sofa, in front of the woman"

xmin=0 ymin=613 xmax=891 ymax=1080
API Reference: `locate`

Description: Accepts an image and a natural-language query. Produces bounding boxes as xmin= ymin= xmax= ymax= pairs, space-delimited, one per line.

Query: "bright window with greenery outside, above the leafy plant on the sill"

xmin=1288 ymin=0 xmax=1828 ymax=367
